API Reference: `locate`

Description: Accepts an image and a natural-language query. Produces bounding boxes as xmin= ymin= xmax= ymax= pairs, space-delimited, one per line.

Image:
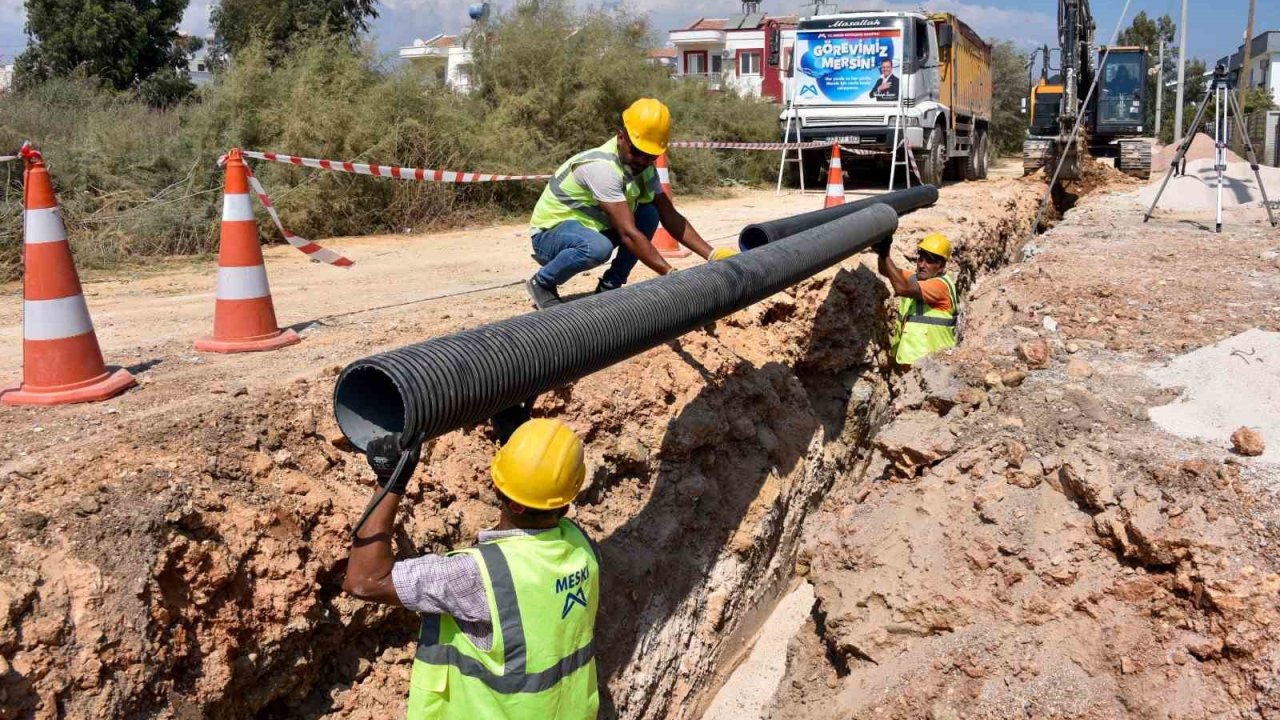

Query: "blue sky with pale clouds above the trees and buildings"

xmin=0 ymin=0 xmax=1280 ymax=64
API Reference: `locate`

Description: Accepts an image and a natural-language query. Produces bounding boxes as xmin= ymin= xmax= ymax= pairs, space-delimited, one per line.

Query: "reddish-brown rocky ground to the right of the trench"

xmin=769 ymin=178 xmax=1280 ymax=720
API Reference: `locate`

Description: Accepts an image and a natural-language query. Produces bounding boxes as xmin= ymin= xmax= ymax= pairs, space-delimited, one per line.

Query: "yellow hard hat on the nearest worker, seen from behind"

xmin=490 ymin=419 xmax=586 ymax=510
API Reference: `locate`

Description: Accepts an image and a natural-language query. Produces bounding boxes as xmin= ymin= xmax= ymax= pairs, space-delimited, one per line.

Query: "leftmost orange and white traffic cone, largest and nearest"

xmin=0 ymin=146 xmax=134 ymax=405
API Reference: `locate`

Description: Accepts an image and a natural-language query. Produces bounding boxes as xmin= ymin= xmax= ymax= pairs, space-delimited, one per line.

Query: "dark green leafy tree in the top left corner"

xmin=15 ymin=0 xmax=191 ymax=92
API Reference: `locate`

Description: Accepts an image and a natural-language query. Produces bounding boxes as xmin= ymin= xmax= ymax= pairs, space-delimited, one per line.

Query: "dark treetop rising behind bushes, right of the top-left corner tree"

xmin=210 ymin=0 xmax=378 ymax=59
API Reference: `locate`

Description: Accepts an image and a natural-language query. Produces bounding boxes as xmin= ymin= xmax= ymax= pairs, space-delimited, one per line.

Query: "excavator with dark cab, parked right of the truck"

xmin=1023 ymin=0 xmax=1153 ymax=181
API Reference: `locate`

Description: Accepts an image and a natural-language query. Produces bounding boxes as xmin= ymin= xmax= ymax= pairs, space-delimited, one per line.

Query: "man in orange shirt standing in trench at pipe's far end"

xmin=876 ymin=233 xmax=960 ymax=368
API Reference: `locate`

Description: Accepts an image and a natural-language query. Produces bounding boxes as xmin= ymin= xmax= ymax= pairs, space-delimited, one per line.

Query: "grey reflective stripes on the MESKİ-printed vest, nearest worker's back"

xmin=416 ymin=543 xmax=595 ymax=694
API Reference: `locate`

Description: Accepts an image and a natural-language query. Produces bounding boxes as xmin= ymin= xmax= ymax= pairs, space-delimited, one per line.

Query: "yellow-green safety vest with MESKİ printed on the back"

xmin=407 ymin=519 xmax=600 ymax=720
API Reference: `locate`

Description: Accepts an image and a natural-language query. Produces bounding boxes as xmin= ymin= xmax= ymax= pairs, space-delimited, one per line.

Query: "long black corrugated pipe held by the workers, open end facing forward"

xmin=334 ymin=204 xmax=897 ymax=450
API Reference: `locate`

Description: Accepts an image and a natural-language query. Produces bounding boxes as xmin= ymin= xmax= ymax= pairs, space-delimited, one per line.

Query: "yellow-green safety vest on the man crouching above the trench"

xmin=529 ymin=137 xmax=658 ymax=232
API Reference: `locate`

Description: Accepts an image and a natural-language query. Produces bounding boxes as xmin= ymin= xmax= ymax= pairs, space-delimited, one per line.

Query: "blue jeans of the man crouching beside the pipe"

xmin=532 ymin=202 xmax=658 ymax=287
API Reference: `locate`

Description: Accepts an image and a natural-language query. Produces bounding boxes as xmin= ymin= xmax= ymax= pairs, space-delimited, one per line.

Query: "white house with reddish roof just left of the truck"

xmin=668 ymin=3 xmax=796 ymax=102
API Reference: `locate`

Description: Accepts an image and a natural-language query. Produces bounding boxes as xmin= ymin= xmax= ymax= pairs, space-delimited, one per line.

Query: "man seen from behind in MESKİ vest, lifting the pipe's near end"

xmin=342 ymin=419 xmax=600 ymax=720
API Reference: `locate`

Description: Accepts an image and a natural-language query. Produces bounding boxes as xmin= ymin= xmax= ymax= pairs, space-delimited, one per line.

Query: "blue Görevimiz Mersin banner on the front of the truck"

xmin=800 ymin=28 xmax=901 ymax=102
